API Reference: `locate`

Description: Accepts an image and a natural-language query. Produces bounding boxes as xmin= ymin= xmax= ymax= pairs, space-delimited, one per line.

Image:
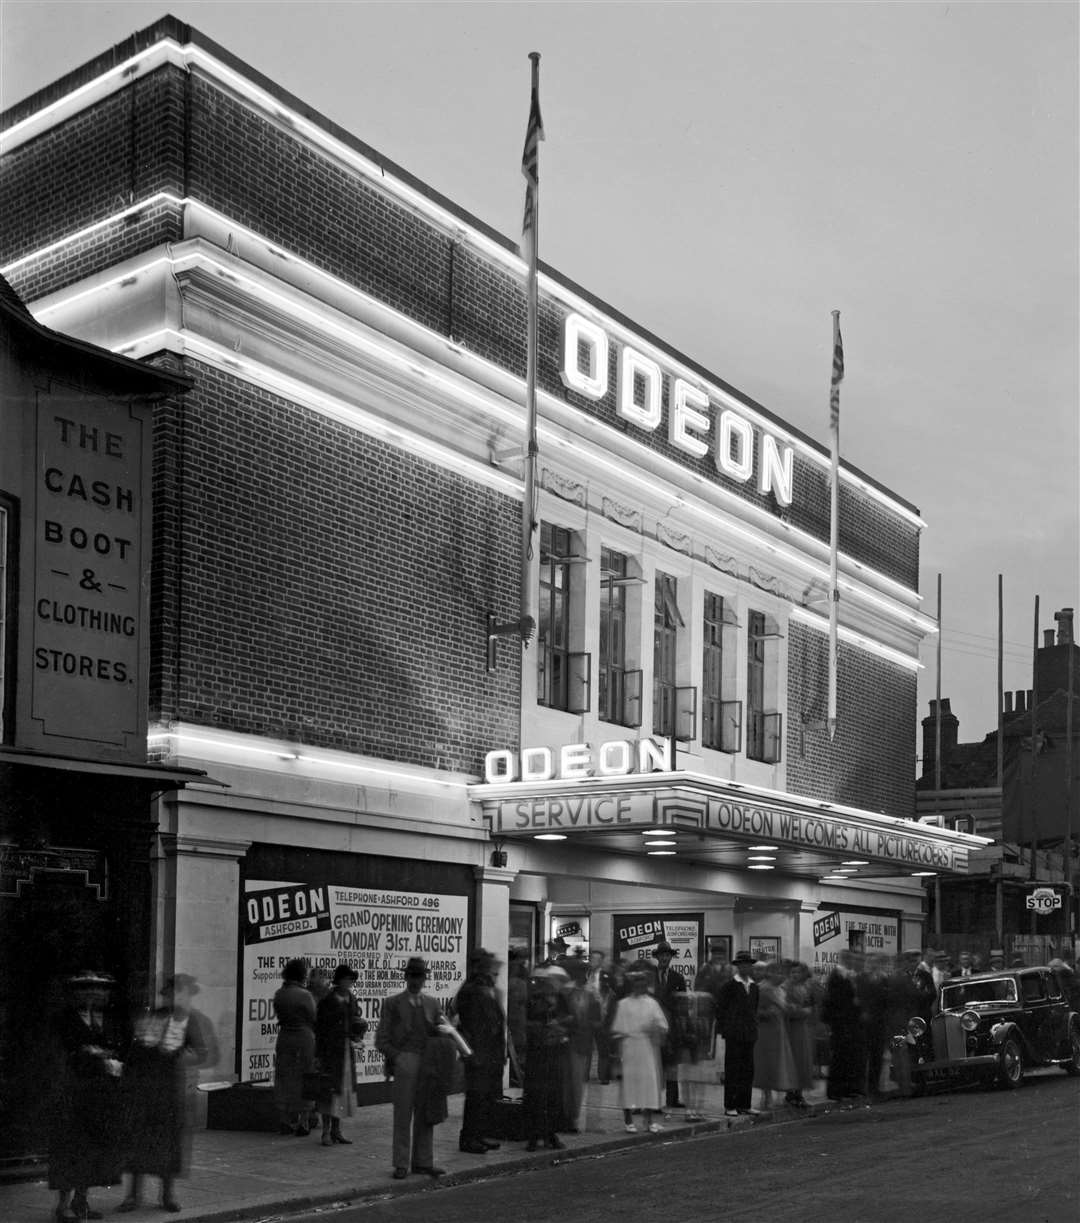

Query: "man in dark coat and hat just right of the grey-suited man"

xmin=454 ymin=947 xmax=506 ymax=1155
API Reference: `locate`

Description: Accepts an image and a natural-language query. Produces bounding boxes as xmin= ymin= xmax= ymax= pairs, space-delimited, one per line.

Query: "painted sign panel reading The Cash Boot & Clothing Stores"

xmin=26 ymin=391 xmax=149 ymax=759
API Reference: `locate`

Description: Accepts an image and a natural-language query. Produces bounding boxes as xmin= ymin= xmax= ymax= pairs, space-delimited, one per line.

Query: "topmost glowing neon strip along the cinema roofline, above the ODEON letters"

xmin=0 ymin=38 xmax=926 ymax=531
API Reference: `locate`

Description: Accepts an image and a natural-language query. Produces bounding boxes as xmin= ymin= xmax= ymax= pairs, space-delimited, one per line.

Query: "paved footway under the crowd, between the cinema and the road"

xmin=0 ymin=1063 xmax=865 ymax=1223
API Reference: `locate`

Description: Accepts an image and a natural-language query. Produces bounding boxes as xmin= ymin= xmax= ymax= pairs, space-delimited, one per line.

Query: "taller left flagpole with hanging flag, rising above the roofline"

xmin=521 ymin=51 xmax=544 ymax=650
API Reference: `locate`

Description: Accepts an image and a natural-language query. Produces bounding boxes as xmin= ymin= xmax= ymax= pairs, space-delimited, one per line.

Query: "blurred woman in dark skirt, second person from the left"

xmin=117 ymin=972 xmax=218 ymax=1211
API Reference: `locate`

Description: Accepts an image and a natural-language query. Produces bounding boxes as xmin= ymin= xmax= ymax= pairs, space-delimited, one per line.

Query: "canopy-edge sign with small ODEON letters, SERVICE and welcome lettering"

xmin=484 ymin=737 xmax=967 ymax=871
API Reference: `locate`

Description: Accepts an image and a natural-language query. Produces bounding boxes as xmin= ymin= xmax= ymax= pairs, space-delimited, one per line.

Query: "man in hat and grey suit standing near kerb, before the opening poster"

xmin=375 ymin=956 xmax=445 ymax=1180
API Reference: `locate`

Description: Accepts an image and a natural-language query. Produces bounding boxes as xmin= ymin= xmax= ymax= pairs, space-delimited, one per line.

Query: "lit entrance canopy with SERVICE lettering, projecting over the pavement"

xmin=470 ymin=772 xmax=991 ymax=882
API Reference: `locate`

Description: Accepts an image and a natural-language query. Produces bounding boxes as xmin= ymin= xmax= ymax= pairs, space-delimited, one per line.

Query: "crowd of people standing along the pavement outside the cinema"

xmin=49 ymin=940 xmax=1080 ymax=1208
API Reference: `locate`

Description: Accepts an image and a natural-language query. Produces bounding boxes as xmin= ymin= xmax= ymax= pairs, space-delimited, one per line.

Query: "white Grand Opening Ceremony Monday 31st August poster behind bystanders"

xmin=240 ymin=879 xmax=468 ymax=1082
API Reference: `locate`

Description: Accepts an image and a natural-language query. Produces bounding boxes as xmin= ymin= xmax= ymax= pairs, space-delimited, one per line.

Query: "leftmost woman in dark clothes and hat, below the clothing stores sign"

xmin=49 ymin=971 xmax=122 ymax=1223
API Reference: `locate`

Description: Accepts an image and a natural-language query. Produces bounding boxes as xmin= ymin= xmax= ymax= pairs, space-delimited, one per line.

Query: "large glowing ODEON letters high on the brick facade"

xmin=560 ymin=313 xmax=794 ymax=505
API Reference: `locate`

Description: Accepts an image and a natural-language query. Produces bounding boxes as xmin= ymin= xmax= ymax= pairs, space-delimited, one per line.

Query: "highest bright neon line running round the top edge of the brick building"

xmin=4 ymin=39 xmax=926 ymax=530
